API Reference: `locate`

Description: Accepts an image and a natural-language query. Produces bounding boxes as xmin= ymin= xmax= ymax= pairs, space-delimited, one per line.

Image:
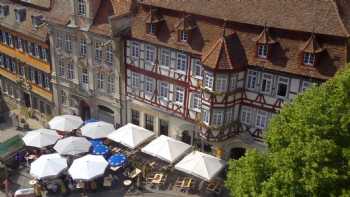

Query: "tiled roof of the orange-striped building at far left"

xmin=0 ymin=0 xmax=66 ymax=42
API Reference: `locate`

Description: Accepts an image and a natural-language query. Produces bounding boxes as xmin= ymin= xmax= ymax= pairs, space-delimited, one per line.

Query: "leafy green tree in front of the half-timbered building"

xmin=226 ymin=68 xmax=350 ymax=196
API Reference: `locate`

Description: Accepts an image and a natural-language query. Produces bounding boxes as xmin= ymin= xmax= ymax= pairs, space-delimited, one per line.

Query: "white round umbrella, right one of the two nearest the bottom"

xmin=68 ymin=155 xmax=108 ymax=181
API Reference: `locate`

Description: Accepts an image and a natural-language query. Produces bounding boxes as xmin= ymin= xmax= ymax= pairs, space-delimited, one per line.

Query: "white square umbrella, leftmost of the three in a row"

xmin=107 ymin=123 xmax=154 ymax=149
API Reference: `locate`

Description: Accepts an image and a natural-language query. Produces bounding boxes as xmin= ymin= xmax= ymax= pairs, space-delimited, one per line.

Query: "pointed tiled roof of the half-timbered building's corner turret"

xmin=202 ymin=32 xmax=242 ymax=69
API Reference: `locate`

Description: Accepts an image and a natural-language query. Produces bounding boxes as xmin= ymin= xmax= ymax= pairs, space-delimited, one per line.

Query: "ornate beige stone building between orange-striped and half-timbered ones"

xmin=49 ymin=0 xmax=132 ymax=125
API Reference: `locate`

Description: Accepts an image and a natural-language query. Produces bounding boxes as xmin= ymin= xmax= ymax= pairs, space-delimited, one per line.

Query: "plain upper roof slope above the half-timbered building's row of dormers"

xmin=139 ymin=0 xmax=350 ymax=37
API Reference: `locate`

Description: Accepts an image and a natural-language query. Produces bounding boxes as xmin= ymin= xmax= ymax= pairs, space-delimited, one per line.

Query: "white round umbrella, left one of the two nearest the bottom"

xmin=30 ymin=153 xmax=67 ymax=179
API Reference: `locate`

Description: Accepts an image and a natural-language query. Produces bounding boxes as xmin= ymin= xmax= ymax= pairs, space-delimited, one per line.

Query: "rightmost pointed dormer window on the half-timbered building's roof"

xmin=301 ymin=34 xmax=324 ymax=66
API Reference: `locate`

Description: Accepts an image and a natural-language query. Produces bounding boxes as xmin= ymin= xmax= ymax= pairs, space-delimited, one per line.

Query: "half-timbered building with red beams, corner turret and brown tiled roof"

xmin=125 ymin=0 xmax=349 ymax=158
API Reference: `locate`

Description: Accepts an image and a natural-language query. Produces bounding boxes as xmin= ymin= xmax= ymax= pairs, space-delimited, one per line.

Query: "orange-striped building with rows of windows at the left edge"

xmin=0 ymin=0 xmax=61 ymax=120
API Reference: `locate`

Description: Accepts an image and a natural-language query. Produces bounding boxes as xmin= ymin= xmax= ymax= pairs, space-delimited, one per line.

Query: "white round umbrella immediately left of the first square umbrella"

xmin=80 ymin=121 xmax=114 ymax=139
